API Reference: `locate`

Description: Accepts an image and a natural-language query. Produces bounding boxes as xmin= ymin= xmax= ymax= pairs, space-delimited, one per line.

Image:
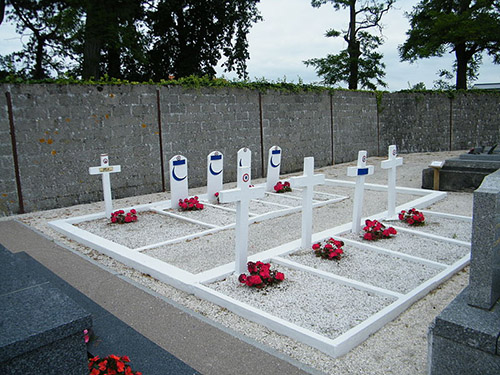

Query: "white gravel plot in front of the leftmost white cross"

xmin=75 ymin=211 xmax=207 ymax=249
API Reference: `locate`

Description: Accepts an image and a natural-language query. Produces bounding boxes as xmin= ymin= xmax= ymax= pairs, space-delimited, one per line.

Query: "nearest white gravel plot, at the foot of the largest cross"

xmin=208 ymin=265 xmax=395 ymax=339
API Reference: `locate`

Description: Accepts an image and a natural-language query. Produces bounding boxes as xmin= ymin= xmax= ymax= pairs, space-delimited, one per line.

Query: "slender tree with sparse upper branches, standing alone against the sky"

xmin=304 ymin=0 xmax=395 ymax=90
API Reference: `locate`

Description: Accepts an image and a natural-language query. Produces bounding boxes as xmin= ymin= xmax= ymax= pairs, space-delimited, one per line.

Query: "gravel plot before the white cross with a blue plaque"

xmin=342 ymin=232 xmax=470 ymax=265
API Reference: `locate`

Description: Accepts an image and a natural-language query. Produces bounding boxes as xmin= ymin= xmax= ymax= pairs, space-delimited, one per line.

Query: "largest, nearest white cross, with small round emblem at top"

xmin=219 ymin=166 xmax=265 ymax=274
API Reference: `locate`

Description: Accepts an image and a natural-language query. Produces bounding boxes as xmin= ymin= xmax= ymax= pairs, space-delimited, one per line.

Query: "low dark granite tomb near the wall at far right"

xmin=422 ymin=146 xmax=500 ymax=191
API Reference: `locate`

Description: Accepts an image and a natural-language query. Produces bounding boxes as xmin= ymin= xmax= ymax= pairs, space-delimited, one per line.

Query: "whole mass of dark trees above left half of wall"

xmin=0 ymin=0 xmax=261 ymax=81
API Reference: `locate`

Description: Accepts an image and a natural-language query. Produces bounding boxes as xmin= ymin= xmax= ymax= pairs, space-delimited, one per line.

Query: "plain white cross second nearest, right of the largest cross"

xmin=290 ymin=157 xmax=325 ymax=249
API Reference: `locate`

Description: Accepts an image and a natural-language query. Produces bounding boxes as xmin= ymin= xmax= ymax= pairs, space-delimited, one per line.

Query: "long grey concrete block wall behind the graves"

xmin=0 ymin=84 xmax=500 ymax=215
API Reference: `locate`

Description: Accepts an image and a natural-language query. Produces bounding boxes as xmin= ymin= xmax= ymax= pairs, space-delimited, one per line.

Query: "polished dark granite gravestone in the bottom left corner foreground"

xmin=0 ymin=245 xmax=92 ymax=375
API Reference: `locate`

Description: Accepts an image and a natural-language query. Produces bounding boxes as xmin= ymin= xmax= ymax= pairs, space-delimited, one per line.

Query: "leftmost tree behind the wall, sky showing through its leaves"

xmin=4 ymin=0 xmax=80 ymax=79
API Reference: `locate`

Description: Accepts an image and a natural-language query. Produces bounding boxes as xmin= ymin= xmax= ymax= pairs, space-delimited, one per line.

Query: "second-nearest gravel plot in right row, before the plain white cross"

xmin=285 ymin=245 xmax=442 ymax=294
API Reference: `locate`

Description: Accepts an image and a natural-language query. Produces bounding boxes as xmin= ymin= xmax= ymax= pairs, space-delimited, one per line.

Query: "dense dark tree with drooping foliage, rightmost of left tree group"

xmin=147 ymin=0 xmax=261 ymax=80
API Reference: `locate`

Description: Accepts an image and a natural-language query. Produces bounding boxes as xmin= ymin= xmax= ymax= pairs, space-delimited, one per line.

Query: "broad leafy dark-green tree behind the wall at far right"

xmin=399 ymin=0 xmax=500 ymax=89
